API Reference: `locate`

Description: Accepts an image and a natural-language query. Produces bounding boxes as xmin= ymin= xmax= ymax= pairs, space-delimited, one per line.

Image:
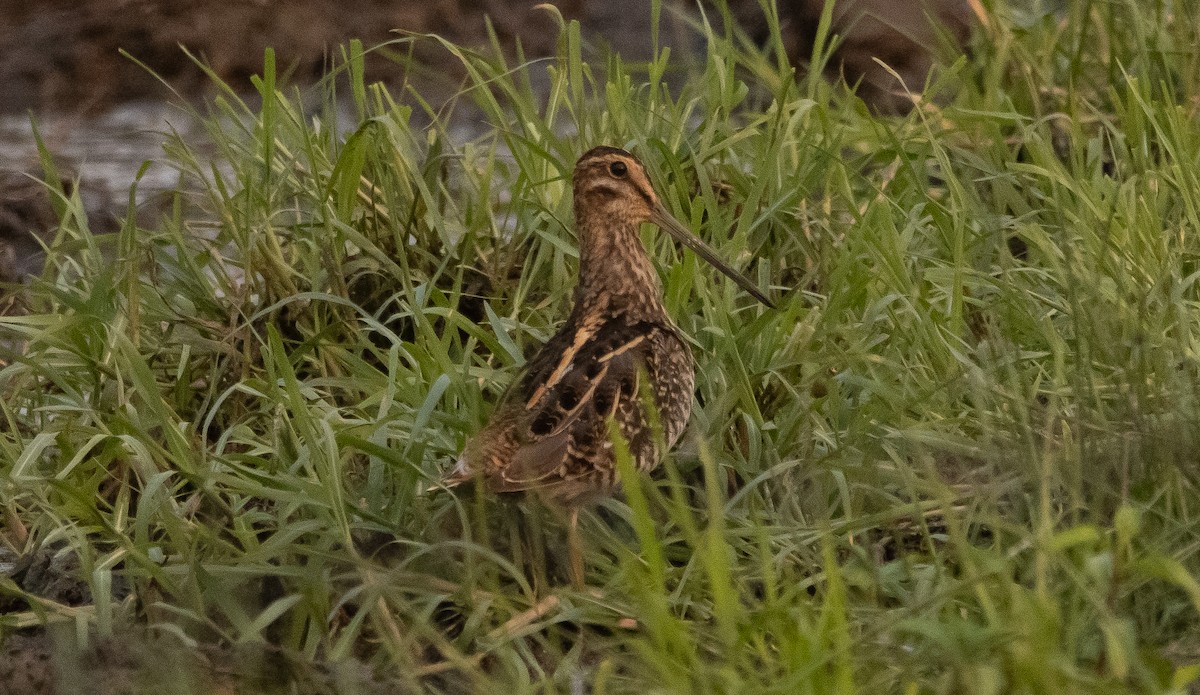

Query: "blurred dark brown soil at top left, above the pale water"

xmin=0 ymin=0 xmax=581 ymax=112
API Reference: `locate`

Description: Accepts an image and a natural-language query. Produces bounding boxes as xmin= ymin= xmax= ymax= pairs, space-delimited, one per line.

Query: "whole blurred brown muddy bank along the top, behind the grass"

xmin=0 ymin=0 xmax=973 ymax=114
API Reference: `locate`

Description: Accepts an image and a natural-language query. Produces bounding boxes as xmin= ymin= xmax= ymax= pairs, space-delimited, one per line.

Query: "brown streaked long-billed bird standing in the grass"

xmin=443 ymin=145 xmax=773 ymax=588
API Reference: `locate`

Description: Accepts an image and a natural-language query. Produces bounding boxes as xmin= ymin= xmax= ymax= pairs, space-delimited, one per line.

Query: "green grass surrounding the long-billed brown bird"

xmin=0 ymin=0 xmax=1200 ymax=694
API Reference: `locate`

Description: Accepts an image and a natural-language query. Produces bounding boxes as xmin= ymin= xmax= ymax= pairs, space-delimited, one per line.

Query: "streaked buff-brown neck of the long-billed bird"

xmin=575 ymin=215 xmax=667 ymax=319
